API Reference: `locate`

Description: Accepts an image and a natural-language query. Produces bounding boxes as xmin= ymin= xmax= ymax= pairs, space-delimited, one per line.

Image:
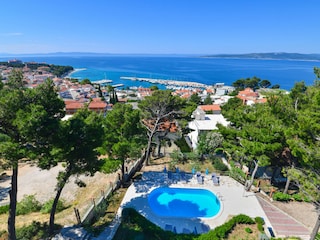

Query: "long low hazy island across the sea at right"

xmin=203 ymin=52 xmax=320 ymax=61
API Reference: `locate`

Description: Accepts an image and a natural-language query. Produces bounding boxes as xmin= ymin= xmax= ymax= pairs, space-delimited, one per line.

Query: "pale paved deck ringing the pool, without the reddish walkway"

xmin=118 ymin=172 xmax=270 ymax=233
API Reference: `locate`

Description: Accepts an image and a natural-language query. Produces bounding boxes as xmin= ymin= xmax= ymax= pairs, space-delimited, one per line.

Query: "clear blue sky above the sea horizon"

xmin=0 ymin=0 xmax=320 ymax=54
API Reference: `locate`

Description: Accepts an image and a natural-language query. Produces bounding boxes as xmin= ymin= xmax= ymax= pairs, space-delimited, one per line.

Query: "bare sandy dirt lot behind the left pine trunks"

xmin=0 ymin=164 xmax=118 ymax=230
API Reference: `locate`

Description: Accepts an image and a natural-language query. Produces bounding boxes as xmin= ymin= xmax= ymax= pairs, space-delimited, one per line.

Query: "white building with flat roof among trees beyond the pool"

xmin=188 ymin=107 xmax=229 ymax=149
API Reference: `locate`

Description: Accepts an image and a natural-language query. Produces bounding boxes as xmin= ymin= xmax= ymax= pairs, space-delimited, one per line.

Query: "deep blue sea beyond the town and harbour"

xmin=0 ymin=55 xmax=320 ymax=90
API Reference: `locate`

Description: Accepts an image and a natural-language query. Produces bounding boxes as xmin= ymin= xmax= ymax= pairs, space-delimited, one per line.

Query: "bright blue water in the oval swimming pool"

xmin=148 ymin=187 xmax=221 ymax=218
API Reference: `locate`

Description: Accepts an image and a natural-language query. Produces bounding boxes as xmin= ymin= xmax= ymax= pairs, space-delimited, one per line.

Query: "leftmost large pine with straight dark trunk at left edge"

xmin=0 ymin=70 xmax=64 ymax=239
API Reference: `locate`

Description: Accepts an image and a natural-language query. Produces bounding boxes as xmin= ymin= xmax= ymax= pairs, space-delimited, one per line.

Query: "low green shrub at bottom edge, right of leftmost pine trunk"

xmin=16 ymin=221 xmax=48 ymax=240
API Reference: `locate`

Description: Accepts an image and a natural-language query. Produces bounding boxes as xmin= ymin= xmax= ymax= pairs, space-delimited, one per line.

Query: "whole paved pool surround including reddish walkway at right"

xmin=94 ymin=172 xmax=310 ymax=240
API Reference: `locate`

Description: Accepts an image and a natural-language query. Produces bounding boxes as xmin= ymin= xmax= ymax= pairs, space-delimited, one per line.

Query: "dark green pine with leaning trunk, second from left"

xmin=49 ymin=108 xmax=104 ymax=233
